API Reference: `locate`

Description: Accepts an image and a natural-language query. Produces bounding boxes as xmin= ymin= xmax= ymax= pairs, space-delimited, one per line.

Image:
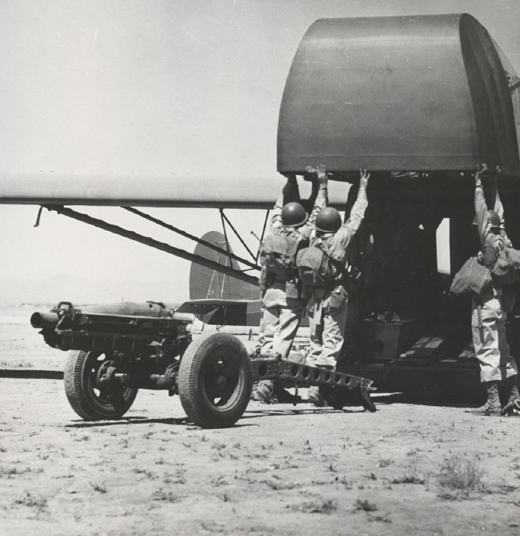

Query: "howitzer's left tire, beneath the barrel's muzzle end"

xmin=64 ymin=350 xmax=137 ymax=421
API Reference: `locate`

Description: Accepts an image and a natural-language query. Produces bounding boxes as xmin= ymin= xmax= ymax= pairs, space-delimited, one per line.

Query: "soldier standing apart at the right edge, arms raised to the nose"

xmin=471 ymin=164 xmax=520 ymax=415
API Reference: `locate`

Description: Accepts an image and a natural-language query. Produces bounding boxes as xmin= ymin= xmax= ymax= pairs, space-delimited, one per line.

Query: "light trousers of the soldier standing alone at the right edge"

xmin=471 ymin=297 xmax=518 ymax=382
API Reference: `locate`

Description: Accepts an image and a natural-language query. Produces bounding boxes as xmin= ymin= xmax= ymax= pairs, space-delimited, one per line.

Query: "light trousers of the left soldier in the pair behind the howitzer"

xmin=257 ymin=289 xmax=305 ymax=359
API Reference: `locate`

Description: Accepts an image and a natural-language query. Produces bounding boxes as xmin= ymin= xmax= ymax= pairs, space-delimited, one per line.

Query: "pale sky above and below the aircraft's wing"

xmin=0 ymin=0 xmax=520 ymax=303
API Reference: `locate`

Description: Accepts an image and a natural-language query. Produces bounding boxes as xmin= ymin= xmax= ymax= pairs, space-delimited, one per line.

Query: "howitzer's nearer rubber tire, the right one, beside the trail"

xmin=179 ymin=333 xmax=253 ymax=428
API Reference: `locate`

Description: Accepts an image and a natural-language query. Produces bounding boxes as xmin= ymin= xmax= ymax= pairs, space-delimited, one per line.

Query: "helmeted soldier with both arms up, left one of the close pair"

xmin=253 ymin=170 xmax=327 ymax=402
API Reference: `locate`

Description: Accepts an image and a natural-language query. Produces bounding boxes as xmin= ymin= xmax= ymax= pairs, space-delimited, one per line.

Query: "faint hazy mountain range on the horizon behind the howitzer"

xmin=0 ymin=276 xmax=188 ymax=305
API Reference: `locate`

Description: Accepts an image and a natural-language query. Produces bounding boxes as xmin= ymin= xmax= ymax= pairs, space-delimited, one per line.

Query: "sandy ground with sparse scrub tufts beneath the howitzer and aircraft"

xmin=0 ymin=308 xmax=520 ymax=536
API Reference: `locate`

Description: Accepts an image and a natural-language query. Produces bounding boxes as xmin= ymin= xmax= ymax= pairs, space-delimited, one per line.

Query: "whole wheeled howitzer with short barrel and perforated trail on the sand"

xmin=31 ymin=302 xmax=375 ymax=428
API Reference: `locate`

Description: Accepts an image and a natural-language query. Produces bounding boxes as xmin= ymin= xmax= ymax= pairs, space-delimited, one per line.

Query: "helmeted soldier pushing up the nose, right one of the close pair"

xmin=306 ymin=166 xmax=370 ymax=405
